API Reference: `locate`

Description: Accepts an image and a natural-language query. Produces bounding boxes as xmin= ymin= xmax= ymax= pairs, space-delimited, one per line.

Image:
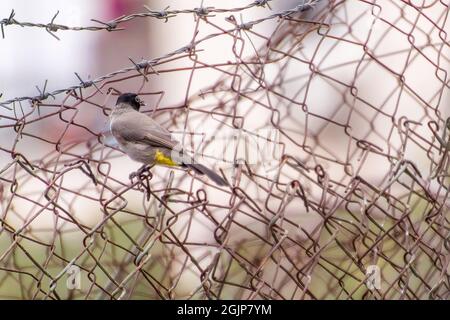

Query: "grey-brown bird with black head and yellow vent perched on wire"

xmin=110 ymin=93 xmax=227 ymax=186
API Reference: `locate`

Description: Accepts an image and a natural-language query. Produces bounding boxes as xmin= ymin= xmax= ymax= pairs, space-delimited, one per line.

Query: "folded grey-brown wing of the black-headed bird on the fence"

xmin=112 ymin=112 xmax=178 ymax=149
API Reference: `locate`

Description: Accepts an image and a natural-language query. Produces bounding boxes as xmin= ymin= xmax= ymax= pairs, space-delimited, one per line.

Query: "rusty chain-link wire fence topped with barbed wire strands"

xmin=0 ymin=1 xmax=450 ymax=299
